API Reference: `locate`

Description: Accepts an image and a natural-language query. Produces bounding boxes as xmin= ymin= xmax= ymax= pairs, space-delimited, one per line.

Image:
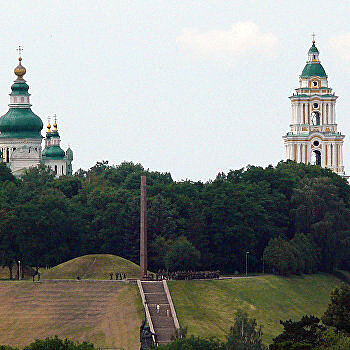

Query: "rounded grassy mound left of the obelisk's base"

xmin=41 ymin=254 xmax=140 ymax=280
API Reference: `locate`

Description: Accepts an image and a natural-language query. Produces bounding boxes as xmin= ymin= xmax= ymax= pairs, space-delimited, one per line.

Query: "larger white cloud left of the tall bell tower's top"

xmin=177 ymin=22 xmax=278 ymax=58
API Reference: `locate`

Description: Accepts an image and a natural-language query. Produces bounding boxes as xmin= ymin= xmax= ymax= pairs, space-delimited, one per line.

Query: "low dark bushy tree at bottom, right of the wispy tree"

xmin=271 ymin=315 xmax=324 ymax=349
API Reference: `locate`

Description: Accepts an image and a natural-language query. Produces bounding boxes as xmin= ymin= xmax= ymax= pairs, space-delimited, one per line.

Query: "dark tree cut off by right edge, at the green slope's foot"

xmin=322 ymin=283 xmax=350 ymax=335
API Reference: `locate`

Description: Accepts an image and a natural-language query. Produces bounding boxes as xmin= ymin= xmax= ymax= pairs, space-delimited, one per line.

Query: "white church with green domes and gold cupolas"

xmin=0 ymin=50 xmax=73 ymax=177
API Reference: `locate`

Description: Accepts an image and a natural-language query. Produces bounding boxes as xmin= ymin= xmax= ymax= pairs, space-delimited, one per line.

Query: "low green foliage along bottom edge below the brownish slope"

xmin=23 ymin=336 xmax=95 ymax=350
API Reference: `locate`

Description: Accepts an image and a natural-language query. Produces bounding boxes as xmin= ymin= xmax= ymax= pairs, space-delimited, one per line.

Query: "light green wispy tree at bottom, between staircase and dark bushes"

xmin=226 ymin=309 xmax=265 ymax=350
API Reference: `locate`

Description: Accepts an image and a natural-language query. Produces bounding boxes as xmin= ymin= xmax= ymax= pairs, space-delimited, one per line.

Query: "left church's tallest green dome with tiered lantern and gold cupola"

xmin=0 ymin=57 xmax=43 ymax=138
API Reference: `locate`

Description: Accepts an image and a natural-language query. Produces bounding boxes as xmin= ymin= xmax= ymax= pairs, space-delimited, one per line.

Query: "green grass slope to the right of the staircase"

xmin=168 ymin=274 xmax=341 ymax=343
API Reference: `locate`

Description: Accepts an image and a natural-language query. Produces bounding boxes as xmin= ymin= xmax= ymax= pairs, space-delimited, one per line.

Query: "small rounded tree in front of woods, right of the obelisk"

xmin=165 ymin=236 xmax=200 ymax=271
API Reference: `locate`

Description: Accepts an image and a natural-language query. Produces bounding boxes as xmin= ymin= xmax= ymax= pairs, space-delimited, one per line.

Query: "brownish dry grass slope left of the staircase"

xmin=0 ymin=280 xmax=144 ymax=350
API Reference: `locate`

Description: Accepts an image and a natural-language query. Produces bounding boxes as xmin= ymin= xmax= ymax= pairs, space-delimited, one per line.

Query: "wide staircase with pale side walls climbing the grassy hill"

xmin=141 ymin=281 xmax=176 ymax=345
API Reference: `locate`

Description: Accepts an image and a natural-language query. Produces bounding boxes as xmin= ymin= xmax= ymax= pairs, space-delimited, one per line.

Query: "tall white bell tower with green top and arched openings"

xmin=283 ymin=40 xmax=345 ymax=176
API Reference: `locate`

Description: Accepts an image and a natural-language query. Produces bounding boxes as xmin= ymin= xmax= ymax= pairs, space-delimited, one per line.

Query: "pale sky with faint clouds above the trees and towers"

xmin=0 ymin=0 xmax=350 ymax=181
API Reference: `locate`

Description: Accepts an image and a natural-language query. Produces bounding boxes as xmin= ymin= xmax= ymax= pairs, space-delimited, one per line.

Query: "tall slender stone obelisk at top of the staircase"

xmin=140 ymin=176 xmax=147 ymax=279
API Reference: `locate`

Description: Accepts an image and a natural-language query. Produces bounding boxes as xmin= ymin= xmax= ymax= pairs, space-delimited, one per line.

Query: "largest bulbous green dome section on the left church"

xmin=0 ymin=108 xmax=43 ymax=138
